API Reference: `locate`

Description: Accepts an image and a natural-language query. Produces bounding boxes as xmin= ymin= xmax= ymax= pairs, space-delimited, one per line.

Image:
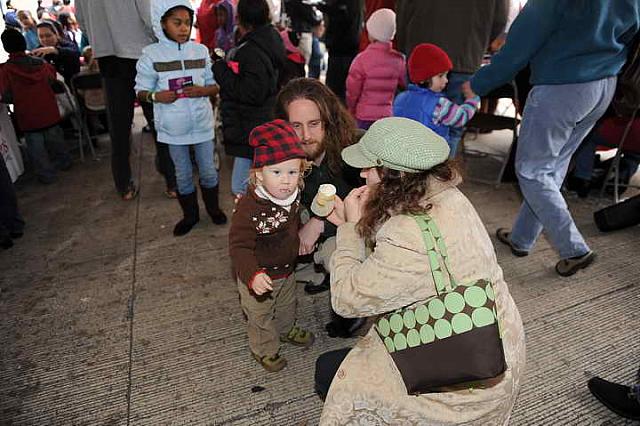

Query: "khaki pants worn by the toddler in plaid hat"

xmin=238 ymin=273 xmax=297 ymax=357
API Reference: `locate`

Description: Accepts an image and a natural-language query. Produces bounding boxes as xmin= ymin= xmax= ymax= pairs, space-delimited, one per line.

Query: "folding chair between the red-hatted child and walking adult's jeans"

xmin=462 ymin=82 xmax=520 ymax=185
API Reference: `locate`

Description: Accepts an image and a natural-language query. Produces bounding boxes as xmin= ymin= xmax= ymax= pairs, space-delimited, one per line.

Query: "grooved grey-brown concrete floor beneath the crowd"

xmin=0 ymin=111 xmax=640 ymax=426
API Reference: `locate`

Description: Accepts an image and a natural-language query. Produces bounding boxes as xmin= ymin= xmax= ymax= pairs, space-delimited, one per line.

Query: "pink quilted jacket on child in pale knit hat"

xmin=347 ymin=42 xmax=406 ymax=121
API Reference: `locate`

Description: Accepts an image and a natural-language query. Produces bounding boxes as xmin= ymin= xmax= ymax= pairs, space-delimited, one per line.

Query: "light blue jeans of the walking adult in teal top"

xmin=511 ymin=77 xmax=616 ymax=259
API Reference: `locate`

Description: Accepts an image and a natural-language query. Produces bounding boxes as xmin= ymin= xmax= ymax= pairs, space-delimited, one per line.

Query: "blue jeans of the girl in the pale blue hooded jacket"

xmin=169 ymin=141 xmax=218 ymax=195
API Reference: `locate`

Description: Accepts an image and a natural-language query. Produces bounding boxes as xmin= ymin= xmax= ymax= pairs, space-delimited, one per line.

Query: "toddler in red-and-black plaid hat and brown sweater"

xmin=229 ymin=120 xmax=314 ymax=371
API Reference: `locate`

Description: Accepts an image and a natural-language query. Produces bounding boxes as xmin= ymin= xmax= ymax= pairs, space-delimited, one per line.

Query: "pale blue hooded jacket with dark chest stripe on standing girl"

xmin=135 ymin=0 xmax=215 ymax=145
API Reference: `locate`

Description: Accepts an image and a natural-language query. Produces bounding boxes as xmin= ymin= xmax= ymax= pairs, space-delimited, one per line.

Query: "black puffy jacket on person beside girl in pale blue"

xmin=213 ymin=25 xmax=286 ymax=158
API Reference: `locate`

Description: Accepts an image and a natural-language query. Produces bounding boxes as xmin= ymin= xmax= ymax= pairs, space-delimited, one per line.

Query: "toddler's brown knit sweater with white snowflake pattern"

xmin=229 ymin=189 xmax=300 ymax=285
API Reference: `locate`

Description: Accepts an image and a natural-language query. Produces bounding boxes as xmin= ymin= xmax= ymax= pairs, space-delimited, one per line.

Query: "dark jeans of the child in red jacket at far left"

xmin=24 ymin=125 xmax=71 ymax=179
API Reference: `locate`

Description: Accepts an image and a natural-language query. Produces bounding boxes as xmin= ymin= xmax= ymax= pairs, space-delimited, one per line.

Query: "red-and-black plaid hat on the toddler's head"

xmin=249 ymin=120 xmax=306 ymax=169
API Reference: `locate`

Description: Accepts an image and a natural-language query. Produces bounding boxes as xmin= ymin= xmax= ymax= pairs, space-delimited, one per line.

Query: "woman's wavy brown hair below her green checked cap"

xmin=357 ymin=160 xmax=459 ymax=244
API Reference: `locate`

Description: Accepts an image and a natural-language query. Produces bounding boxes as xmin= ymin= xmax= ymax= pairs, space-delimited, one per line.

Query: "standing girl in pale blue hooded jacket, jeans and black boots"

xmin=135 ymin=0 xmax=227 ymax=236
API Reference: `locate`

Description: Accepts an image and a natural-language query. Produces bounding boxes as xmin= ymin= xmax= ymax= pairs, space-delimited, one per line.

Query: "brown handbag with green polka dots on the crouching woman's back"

xmin=375 ymin=215 xmax=506 ymax=394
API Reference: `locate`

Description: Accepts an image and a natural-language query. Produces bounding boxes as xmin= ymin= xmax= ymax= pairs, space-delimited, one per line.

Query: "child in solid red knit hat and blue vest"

xmin=393 ymin=43 xmax=480 ymax=157
